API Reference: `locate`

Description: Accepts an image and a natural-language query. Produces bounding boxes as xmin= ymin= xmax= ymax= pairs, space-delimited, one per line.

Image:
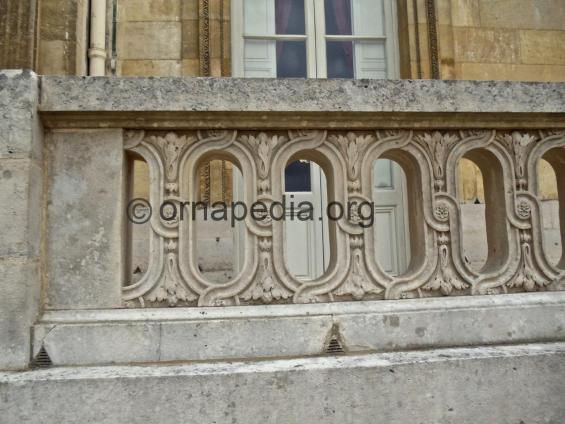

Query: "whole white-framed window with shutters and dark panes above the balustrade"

xmin=232 ymin=0 xmax=398 ymax=78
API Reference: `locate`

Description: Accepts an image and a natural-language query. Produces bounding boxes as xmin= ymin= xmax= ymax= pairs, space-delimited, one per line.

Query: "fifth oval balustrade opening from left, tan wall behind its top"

xmin=457 ymin=149 xmax=509 ymax=272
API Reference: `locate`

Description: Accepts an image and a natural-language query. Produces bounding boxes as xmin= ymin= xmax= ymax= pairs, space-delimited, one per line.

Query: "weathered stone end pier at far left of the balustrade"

xmin=0 ymin=71 xmax=43 ymax=369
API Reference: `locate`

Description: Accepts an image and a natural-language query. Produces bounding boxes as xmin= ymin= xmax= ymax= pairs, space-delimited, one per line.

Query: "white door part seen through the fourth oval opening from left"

xmin=373 ymin=159 xmax=410 ymax=275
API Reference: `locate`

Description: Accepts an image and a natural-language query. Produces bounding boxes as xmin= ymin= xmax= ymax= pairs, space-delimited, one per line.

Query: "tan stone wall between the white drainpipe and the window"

xmin=116 ymin=0 xmax=230 ymax=76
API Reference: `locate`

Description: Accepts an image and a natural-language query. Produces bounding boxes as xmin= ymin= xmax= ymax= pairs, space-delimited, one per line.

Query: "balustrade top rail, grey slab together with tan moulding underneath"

xmin=36 ymin=76 xmax=565 ymax=129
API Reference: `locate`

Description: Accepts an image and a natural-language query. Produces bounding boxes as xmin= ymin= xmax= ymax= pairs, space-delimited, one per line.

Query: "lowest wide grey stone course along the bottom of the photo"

xmin=0 ymin=343 xmax=565 ymax=424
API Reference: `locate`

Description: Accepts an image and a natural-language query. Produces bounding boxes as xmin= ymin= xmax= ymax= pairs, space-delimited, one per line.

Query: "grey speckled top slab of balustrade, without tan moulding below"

xmin=40 ymin=77 xmax=565 ymax=113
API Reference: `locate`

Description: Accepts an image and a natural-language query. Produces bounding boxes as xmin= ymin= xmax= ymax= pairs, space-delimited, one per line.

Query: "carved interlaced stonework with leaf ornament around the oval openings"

xmin=124 ymin=130 xmax=565 ymax=306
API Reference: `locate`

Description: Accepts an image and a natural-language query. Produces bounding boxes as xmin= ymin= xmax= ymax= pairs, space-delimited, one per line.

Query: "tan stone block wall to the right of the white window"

xmin=436 ymin=0 xmax=565 ymax=81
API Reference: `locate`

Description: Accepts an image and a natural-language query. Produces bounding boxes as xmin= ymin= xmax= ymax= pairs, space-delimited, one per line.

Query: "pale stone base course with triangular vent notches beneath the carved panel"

xmin=33 ymin=292 xmax=565 ymax=365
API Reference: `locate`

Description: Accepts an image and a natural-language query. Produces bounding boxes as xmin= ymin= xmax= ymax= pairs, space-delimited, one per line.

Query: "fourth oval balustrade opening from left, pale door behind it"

xmin=371 ymin=154 xmax=425 ymax=276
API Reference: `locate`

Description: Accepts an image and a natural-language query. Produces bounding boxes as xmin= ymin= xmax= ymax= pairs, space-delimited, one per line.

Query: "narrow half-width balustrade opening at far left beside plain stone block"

xmin=124 ymin=153 xmax=151 ymax=285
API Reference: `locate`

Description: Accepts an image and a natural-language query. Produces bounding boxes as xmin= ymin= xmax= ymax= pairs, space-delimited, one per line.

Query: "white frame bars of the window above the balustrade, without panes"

xmin=231 ymin=0 xmax=400 ymax=79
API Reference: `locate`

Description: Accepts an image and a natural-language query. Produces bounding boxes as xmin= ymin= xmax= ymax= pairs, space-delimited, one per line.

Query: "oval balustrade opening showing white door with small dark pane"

xmin=282 ymin=152 xmax=335 ymax=281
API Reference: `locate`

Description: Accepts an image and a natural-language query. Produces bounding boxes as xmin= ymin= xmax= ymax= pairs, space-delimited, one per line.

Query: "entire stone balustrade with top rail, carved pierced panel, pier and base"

xmin=0 ymin=74 xmax=565 ymax=368
